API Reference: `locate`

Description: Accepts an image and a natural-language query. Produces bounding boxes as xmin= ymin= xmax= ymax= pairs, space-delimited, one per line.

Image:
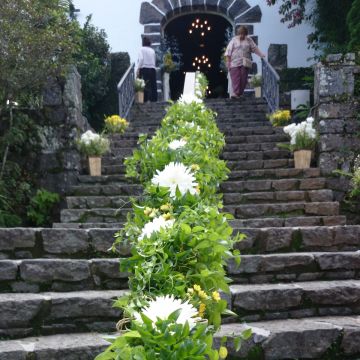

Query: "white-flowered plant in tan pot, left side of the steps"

xmin=78 ymin=130 xmax=110 ymax=176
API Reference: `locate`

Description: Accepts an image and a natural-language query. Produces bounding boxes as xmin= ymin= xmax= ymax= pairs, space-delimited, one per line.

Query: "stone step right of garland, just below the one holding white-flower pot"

xmin=221 ymin=178 xmax=326 ymax=194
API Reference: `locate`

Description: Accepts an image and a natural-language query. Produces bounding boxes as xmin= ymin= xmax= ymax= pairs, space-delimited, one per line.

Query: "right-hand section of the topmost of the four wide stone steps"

xmin=231 ymin=225 xmax=360 ymax=254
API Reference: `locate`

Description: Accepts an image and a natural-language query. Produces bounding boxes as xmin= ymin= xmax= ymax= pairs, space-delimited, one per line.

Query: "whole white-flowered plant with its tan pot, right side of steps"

xmin=282 ymin=117 xmax=317 ymax=169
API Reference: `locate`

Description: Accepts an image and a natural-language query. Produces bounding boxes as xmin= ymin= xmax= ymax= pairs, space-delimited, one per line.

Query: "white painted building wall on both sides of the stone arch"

xmin=74 ymin=0 xmax=313 ymax=67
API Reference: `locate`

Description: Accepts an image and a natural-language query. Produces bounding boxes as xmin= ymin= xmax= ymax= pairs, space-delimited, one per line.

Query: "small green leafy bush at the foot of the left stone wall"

xmin=27 ymin=189 xmax=60 ymax=226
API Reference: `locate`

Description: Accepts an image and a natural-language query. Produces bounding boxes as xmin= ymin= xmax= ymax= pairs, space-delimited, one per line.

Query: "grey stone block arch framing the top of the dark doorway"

xmin=140 ymin=0 xmax=262 ymax=98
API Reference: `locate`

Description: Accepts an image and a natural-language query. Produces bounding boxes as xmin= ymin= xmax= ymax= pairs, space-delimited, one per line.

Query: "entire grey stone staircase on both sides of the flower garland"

xmin=0 ymin=98 xmax=360 ymax=360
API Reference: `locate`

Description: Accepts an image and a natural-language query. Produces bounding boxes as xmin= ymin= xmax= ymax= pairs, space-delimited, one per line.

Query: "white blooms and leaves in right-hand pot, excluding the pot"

xmin=284 ymin=117 xmax=317 ymax=151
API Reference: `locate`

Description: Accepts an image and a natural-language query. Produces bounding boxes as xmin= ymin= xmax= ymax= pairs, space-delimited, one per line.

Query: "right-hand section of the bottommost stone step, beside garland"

xmin=217 ymin=316 xmax=360 ymax=360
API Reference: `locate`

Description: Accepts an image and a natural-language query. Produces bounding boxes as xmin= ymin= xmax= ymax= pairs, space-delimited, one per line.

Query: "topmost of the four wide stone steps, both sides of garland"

xmin=0 ymin=226 xmax=360 ymax=260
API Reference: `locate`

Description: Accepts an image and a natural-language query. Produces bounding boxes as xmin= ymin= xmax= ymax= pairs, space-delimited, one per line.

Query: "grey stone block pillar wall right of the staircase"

xmin=314 ymin=54 xmax=360 ymax=200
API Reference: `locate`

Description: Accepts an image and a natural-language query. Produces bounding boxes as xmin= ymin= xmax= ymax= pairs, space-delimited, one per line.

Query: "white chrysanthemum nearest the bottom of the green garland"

xmin=134 ymin=295 xmax=199 ymax=329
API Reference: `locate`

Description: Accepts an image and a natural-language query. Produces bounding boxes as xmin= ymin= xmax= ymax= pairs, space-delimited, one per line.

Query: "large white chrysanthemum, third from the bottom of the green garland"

xmin=151 ymin=162 xmax=198 ymax=198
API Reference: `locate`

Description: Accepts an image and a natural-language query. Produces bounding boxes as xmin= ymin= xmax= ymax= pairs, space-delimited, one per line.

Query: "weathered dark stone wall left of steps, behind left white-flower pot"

xmin=36 ymin=67 xmax=89 ymax=194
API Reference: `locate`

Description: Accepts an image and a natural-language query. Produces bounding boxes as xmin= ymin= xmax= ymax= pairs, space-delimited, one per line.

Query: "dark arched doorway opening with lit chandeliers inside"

xmin=163 ymin=13 xmax=233 ymax=99
